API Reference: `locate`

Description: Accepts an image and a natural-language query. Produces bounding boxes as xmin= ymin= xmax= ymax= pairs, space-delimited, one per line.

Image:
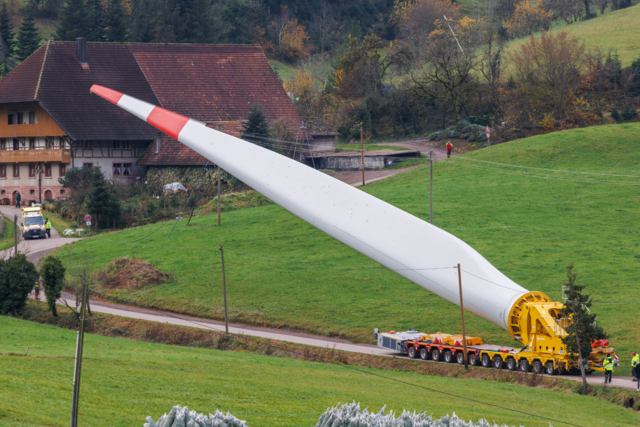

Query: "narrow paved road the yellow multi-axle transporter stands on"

xmin=36 ymin=295 xmax=637 ymax=390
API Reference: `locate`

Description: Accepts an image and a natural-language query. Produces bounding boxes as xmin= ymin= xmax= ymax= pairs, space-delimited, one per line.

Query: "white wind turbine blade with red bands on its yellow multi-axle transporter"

xmin=91 ymin=85 xmax=612 ymax=372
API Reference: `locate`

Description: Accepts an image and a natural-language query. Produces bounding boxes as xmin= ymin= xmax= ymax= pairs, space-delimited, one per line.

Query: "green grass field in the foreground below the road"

xmin=0 ymin=316 xmax=640 ymax=427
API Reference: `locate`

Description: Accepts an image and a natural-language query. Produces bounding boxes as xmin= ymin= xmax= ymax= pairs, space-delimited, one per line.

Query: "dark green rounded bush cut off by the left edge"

xmin=0 ymin=254 xmax=40 ymax=314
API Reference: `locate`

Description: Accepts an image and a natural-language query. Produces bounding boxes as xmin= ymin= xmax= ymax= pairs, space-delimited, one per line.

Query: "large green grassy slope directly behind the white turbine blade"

xmin=52 ymin=123 xmax=640 ymax=375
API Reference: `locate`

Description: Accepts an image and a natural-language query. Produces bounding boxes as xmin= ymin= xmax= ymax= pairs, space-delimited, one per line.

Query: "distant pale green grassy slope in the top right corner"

xmin=507 ymin=4 xmax=640 ymax=67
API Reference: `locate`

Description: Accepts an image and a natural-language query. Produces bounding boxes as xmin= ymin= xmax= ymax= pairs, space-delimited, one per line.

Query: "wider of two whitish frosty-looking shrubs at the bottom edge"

xmin=316 ymin=402 xmax=524 ymax=427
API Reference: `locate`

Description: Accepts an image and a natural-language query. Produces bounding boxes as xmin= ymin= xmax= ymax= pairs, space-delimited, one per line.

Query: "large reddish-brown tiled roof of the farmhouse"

xmin=0 ymin=42 xmax=301 ymax=165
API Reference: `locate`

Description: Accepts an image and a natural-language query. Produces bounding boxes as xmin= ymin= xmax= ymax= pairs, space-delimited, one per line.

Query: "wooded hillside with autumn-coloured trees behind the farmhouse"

xmin=0 ymin=0 xmax=640 ymax=142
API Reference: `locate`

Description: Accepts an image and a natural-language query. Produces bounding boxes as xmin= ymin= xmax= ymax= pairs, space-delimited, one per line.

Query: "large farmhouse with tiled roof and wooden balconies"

xmin=0 ymin=38 xmax=301 ymax=204
